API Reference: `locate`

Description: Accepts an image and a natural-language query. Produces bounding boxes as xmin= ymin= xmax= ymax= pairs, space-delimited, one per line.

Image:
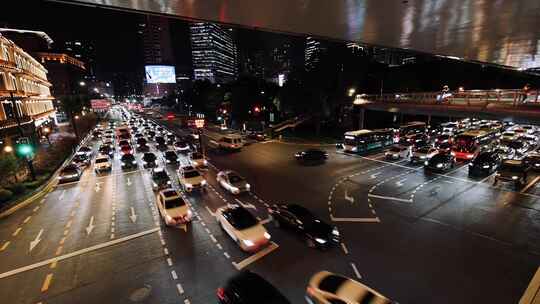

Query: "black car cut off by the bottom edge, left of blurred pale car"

xmin=216 ymin=270 xmax=291 ymax=304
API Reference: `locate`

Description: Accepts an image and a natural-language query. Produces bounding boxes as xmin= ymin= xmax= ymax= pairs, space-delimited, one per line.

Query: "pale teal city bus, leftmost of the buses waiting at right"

xmin=343 ymin=129 xmax=394 ymax=153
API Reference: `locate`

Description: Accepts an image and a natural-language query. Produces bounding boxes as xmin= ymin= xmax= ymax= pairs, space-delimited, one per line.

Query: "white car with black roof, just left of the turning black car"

xmin=216 ymin=205 xmax=270 ymax=252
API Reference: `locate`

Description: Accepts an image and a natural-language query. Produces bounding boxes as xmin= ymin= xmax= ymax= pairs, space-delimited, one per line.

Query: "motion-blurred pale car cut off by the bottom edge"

xmin=306 ymin=271 xmax=392 ymax=304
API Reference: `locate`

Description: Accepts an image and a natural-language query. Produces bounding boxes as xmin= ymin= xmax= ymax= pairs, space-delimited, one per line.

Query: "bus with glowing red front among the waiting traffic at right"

xmin=452 ymin=130 xmax=496 ymax=160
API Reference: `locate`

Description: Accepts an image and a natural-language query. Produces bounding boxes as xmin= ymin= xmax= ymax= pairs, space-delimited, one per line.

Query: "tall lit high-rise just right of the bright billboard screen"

xmin=190 ymin=22 xmax=237 ymax=83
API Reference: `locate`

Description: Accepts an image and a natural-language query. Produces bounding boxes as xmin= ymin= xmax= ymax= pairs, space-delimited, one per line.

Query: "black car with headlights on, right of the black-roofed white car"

xmin=268 ymin=204 xmax=340 ymax=248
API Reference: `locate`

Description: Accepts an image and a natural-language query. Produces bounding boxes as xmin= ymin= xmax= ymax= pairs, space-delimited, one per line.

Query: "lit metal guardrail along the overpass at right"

xmin=361 ymin=90 xmax=540 ymax=107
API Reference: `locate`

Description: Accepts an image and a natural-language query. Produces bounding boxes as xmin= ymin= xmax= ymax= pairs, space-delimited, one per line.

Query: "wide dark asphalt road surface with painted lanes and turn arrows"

xmin=0 ymin=112 xmax=540 ymax=304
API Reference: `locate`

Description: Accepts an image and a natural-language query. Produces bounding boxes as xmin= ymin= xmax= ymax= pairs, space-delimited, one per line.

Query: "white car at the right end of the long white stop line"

xmin=156 ymin=188 xmax=193 ymax=226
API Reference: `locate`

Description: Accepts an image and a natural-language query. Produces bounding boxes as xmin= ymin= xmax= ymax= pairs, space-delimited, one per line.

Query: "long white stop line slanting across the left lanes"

xmin=0 ymin=228 xmax=159 ymax=279
